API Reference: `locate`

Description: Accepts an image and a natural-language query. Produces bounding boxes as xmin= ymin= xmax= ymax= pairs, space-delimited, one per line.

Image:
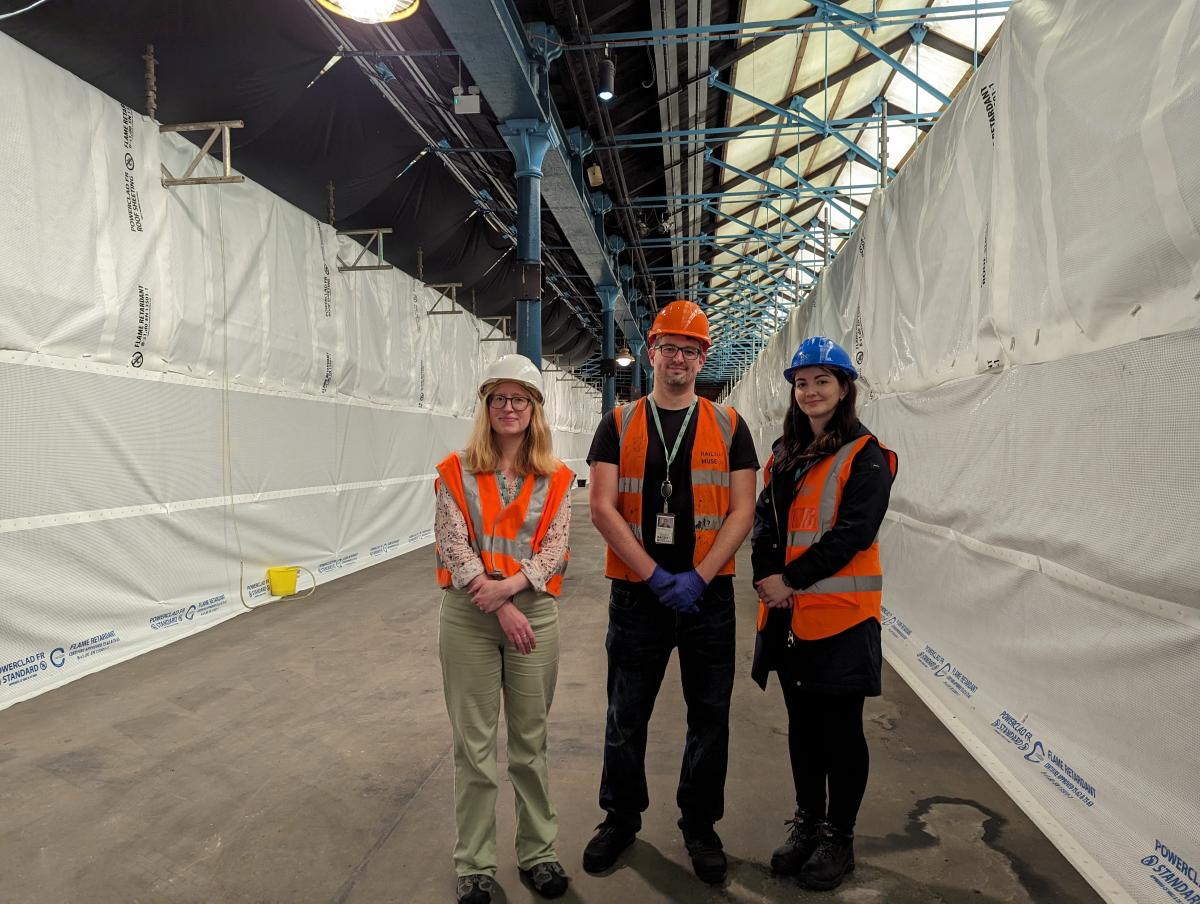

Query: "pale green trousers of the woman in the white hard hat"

xmin=438 ymin=591 xmax=558 ymax=875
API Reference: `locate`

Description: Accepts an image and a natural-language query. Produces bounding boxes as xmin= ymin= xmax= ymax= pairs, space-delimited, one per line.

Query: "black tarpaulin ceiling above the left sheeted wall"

xmin=0 ymin=0 xmax=596 ymax=365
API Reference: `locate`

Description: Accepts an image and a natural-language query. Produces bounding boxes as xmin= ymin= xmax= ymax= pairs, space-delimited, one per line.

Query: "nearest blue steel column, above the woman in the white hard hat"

xmin=499 ymin=119 xmax=558 ymax=367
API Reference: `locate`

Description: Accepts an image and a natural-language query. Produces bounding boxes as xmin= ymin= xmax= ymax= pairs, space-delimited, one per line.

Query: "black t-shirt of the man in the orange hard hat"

xmin=588 ymin=400 xmax=758 ymax=573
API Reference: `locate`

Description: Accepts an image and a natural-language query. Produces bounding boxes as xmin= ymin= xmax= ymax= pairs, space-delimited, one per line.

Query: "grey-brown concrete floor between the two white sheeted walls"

xmin=0 ymin=493 xmax=1098 ymax=904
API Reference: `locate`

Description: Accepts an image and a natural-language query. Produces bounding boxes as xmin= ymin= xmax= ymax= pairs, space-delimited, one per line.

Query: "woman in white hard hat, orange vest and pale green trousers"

xmin=434 ymin=354 xmax=575 ymax=904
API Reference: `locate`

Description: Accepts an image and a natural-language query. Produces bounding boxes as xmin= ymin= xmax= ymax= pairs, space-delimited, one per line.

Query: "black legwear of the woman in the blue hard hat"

xmin=780 ymin=673 xmax=870 ymax=833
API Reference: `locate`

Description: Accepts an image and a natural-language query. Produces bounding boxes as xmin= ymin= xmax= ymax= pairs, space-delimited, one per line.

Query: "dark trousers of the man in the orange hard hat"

xmin=600 ymin=577 xmax=736 ymax=831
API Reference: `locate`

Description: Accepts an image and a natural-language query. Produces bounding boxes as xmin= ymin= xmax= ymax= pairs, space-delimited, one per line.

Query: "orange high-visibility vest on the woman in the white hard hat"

xmin=433 ymin=453 xmax=575 ymax=597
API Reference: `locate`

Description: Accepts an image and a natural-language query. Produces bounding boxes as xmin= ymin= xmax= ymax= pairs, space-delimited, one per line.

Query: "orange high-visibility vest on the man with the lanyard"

xmin=604 ymin=399 xmax=738 ymax=581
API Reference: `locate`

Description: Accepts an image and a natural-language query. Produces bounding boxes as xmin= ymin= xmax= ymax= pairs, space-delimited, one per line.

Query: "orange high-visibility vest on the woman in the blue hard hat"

xmin=758 ymin=436 xmax=896 ymax=640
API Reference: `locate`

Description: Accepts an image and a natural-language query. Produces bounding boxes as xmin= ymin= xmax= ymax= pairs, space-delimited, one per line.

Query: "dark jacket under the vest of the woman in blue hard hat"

xmin=750 ymin=424 xmax=892 ymax=696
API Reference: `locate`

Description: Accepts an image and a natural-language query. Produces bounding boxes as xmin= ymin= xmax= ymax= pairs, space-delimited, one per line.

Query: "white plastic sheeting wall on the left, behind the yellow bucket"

xmin=0 ymin=35 xmax=600 ymax=708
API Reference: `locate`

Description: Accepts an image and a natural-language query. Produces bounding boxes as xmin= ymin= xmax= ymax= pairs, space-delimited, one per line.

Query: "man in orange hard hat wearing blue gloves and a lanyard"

xmin=583 ymin=301 xmax=758 ymax=884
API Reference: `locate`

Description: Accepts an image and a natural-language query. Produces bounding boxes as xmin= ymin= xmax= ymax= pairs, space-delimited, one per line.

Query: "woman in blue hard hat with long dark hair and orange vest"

xmin=751 ymin=336 xmax=896 ymax=890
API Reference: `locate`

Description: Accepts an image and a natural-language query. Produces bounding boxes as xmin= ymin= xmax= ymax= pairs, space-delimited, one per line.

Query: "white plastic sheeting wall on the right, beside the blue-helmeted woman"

xmin=730 ymin=0 xmax=1200 ymax=903
